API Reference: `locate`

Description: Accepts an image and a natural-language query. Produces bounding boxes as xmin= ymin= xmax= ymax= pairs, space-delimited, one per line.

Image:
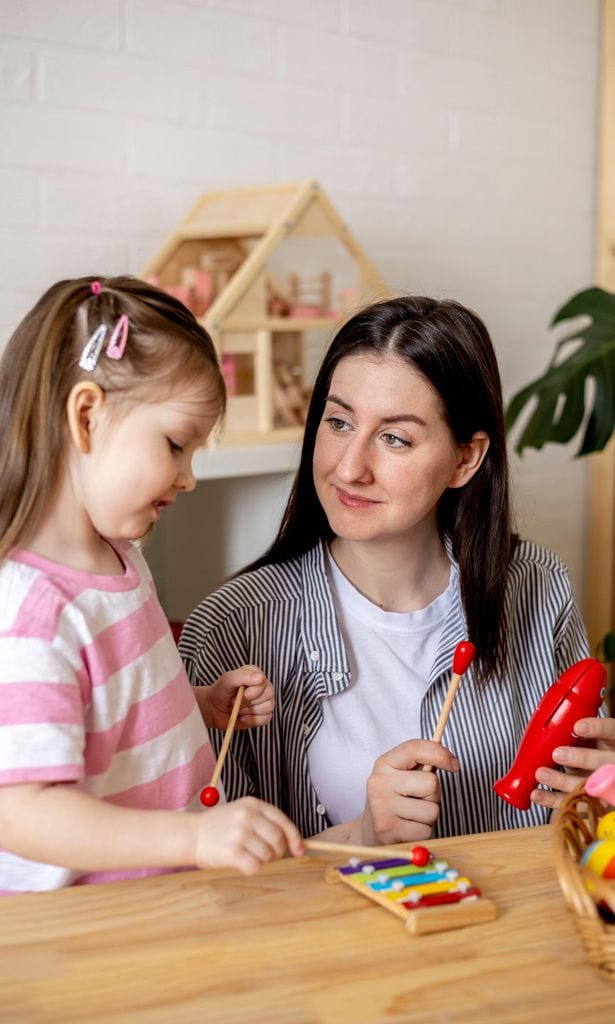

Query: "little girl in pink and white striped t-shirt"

xmin=0 ymin=278 xmax=301 ymax=893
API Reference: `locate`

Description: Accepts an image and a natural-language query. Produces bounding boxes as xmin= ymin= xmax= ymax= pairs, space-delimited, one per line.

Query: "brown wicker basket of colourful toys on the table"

xmin=554 ymin=783 xmax=615 ymax=981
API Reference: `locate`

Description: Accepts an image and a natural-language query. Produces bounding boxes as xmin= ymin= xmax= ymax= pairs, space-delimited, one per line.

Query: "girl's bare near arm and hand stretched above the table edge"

xmin=0 ymin=782 xmax=303 ymax=874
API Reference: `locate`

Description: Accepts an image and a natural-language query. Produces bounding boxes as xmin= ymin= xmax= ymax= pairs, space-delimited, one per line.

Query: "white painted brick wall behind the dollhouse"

xmin=0 ymin=0 xmax=600 ymax=606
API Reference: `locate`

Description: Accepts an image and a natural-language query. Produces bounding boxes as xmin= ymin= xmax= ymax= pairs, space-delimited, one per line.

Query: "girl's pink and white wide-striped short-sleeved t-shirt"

xmin=0 ymin=543 xmax=215 ymax=893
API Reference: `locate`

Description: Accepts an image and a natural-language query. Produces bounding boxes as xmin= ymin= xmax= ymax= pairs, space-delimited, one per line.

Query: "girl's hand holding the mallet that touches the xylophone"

xmin=193 ymin=797 xmax=304 ymax=874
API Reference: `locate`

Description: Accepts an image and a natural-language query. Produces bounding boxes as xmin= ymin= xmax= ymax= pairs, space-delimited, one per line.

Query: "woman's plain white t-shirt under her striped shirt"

xmin=308 ymin=554 xmax=458 ymax=824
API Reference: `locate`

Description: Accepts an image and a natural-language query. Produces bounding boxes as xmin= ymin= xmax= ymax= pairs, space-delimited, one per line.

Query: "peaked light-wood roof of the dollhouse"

xmin=141 ymin=179 xmax=388 ymax=329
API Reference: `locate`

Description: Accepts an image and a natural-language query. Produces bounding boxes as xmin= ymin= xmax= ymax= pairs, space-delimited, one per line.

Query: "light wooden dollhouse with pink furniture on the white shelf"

xmin=141 ymin=180 xmax=388 ymax=444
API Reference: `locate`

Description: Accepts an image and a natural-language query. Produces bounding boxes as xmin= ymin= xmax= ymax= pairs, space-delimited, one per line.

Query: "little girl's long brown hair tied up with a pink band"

xmin=0 ymin=276 xmax=225 ymax=560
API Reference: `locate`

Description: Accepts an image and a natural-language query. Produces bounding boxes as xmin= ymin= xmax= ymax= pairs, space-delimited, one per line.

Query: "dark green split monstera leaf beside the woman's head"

xmin=506 ymin=288 xmax=615 ymax=456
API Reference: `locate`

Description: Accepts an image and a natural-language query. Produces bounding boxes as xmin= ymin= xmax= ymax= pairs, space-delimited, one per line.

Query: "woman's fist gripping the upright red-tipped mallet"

xmin=359 ymin=739 xmax=459 ymax=845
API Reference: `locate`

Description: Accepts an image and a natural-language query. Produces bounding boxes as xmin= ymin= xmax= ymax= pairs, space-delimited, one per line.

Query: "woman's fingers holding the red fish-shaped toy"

xmin=531 ymin=718 xmax=615 ymax=807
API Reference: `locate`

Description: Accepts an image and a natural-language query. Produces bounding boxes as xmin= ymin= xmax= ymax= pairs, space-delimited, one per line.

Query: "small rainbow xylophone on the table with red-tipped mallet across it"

xmin=305 ymin=840 xmax=496 ymax=935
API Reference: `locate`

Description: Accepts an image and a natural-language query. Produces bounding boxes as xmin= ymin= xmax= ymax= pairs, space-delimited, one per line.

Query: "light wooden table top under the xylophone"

xmin=0 ymin=826 xmax=615 ymax=1024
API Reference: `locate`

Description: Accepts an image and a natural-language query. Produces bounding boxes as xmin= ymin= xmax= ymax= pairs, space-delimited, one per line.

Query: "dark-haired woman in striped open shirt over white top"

xmin=180 ymin=297 xmax=615 ymax=843
